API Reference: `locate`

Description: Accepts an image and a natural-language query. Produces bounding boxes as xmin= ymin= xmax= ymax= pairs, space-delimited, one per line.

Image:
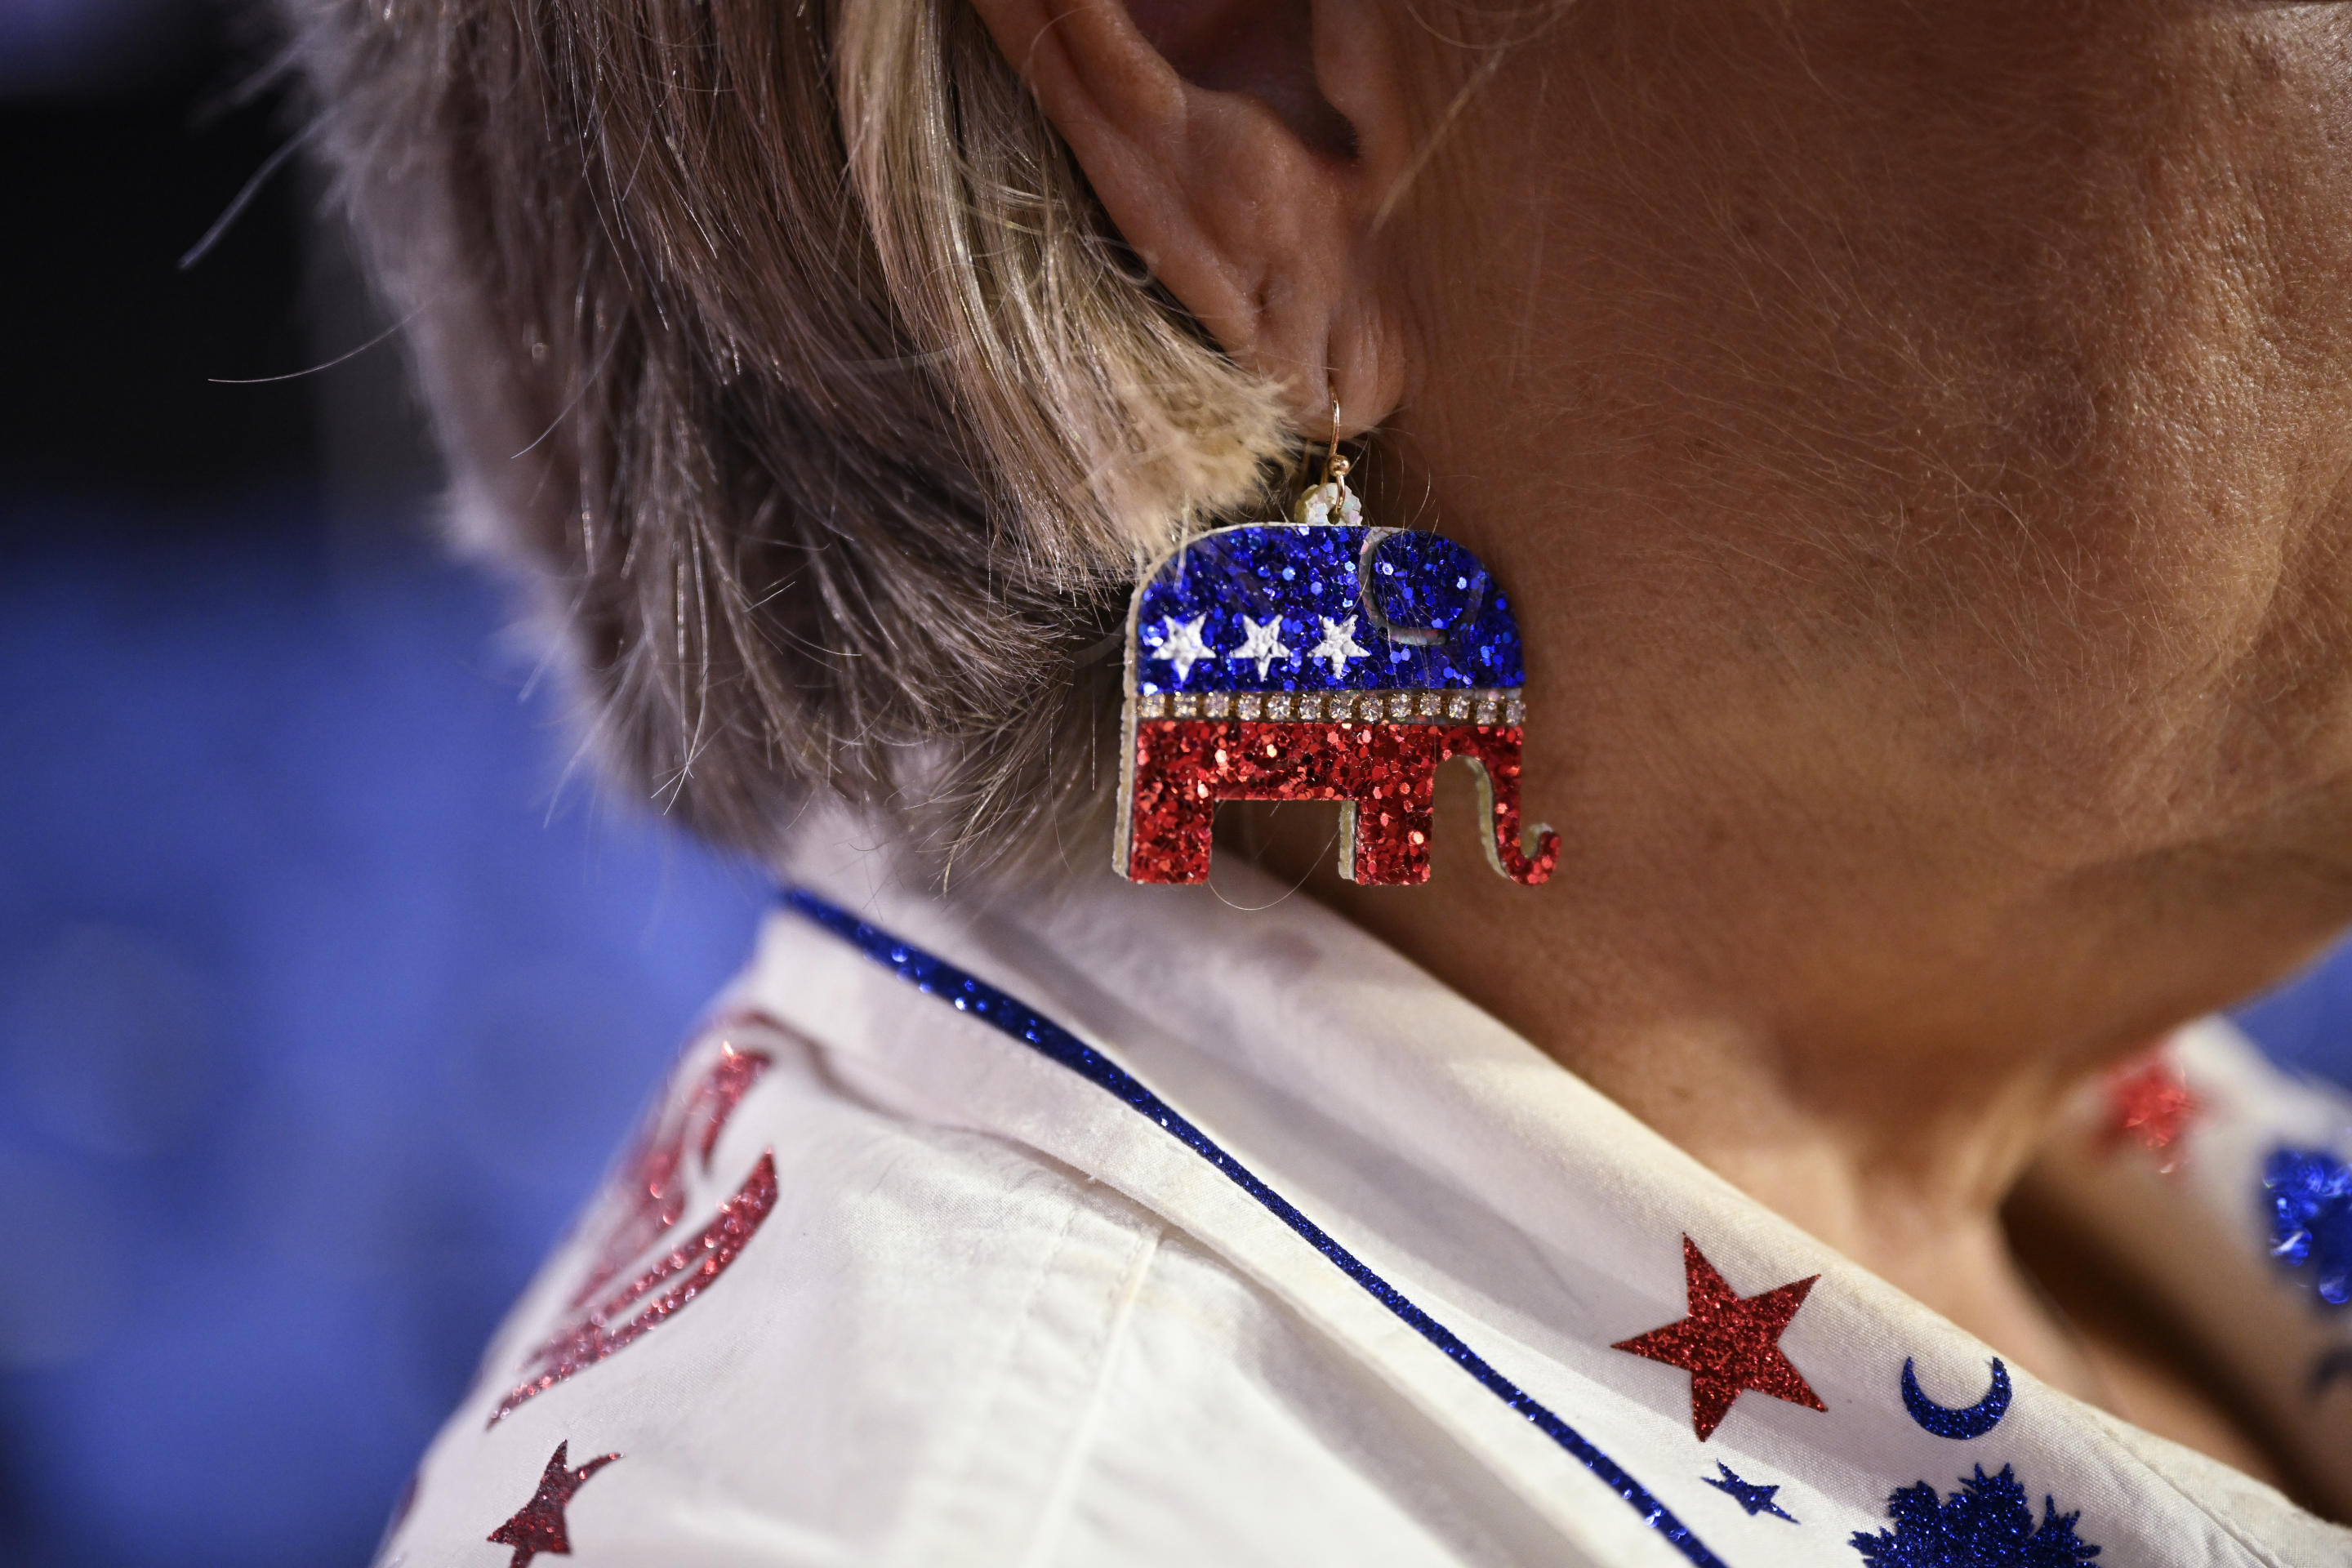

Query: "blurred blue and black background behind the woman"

xmin=0 ymin=0 xmax=2352 ymax=1568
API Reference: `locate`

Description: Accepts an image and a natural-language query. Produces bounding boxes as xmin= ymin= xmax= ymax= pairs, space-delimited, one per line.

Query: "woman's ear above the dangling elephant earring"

xmin=971 ymin=0 xmax=1414 ymax=435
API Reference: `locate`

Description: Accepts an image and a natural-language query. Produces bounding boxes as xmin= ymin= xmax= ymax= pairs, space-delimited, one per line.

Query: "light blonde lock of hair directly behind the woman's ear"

xmin=835 ymin=0 xmax=1286 ymax=576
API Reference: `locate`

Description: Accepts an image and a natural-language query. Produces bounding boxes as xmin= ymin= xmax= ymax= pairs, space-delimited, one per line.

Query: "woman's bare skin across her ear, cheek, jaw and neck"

xmin=976 ymin=0 xmax=2352 ymax=1504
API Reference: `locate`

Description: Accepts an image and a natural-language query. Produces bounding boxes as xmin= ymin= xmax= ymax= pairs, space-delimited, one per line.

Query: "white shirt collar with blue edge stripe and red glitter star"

xmin=746 ymin=835 xmax=2347 ymax=1563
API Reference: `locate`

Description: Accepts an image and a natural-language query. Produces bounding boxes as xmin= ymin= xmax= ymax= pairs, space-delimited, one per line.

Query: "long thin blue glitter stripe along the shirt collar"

xmin=781 ymin=889 xmax=1724 ymax=1568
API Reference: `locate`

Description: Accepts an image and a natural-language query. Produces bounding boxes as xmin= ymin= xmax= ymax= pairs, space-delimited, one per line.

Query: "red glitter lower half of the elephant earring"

xmin=1127 ymin=719 xmax=1559 ymax=886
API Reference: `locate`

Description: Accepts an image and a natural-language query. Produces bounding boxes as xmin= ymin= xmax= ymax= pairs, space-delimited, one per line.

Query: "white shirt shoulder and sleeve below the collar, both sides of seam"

xmin=379 ymin=1016 xmax=1561 ymax=1568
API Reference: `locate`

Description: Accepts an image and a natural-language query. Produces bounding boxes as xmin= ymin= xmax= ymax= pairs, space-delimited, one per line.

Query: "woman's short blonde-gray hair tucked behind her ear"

xmin=283 ymin=0 xmax=1291 ymax=875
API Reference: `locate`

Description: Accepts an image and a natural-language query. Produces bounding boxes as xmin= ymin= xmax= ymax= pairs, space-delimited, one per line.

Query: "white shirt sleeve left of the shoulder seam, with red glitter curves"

xmin=385 ymin=1016 xmax=1160 ymax=1561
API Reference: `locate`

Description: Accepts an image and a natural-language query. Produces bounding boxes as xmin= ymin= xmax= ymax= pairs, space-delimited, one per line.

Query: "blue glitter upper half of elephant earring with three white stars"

xmin=1131 ymin=522 xmax=1526 ymax=693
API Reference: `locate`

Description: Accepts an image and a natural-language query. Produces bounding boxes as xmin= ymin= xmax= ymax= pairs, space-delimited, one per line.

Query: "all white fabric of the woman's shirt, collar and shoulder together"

xmin=379 ymin=827 xmax=2352 ymax=1568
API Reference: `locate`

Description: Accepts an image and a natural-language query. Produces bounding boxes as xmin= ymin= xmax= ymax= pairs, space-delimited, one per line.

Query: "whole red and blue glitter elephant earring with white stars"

xmin=1112 ymin=514 xmax=1559 ymax=886
